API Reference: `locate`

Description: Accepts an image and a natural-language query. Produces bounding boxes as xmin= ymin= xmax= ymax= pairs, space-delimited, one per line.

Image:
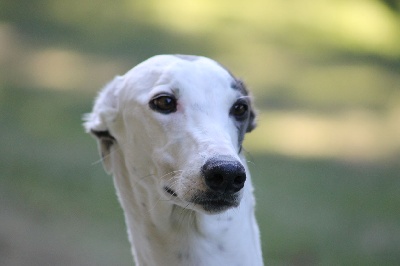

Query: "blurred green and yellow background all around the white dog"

xmin=0 ymin=0 xmax=400 ymax=265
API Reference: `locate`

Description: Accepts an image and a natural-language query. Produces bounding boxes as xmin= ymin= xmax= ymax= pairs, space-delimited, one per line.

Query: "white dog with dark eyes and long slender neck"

xmin=85 ymin=55 xmax=263 ymax=266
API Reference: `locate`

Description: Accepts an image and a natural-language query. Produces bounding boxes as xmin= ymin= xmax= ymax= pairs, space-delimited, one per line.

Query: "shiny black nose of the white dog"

xmin=201 ymin=157 xmax=246 ymax=193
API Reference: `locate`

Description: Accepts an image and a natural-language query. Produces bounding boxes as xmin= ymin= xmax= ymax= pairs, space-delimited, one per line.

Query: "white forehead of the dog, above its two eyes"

xmin=125 ymin=55 xmax=247 ymax=97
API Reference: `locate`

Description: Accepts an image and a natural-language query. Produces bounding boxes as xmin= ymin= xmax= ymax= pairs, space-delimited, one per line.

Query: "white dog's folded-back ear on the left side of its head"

xmin=83 ymin=77 xmax=123 ymax=173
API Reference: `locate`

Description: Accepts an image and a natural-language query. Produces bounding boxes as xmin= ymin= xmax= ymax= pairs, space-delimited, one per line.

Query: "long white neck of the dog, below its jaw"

xmin=113 ymin=149 xmax=263 ymax=266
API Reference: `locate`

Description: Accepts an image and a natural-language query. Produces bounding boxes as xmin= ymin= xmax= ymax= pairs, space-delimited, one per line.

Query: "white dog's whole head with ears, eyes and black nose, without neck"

xmin=85 ymin=56 xmax=255 ymax=213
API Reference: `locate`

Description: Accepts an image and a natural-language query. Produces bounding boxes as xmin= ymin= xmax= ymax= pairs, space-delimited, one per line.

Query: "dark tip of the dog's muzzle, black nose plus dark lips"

xmin=192 ymin=156 xmax=246 ymax=213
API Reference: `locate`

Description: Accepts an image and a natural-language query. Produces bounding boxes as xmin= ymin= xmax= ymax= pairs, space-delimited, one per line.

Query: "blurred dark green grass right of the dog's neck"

xmin=252 ymin=154 xmax=400 ymax=265
